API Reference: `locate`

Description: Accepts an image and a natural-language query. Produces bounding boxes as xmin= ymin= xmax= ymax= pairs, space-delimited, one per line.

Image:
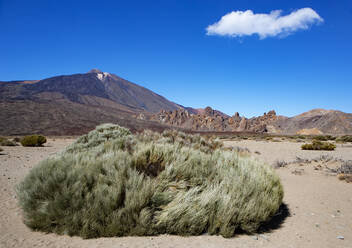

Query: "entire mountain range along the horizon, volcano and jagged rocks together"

xmin=0 ymin=69 xmax=352 ymax=135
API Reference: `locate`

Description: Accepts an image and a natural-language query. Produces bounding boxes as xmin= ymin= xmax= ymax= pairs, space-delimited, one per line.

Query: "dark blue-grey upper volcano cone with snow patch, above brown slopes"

xmin=0 ymin=69 xmax=180 ymax=112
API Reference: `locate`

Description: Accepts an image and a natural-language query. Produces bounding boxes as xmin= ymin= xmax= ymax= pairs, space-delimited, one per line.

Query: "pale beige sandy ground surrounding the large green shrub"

xmin=0 ymin=139 xmax=352 ymax=248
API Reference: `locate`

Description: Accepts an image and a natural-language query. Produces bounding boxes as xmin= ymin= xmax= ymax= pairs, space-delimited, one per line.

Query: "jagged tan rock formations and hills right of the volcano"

xmin=151 ymin=107 xmax=352 ymax=135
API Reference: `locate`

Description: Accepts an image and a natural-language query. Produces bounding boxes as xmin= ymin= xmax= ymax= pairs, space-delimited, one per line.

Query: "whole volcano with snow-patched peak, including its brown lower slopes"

xmin=0 ymin=70 xmax=182 ymax=135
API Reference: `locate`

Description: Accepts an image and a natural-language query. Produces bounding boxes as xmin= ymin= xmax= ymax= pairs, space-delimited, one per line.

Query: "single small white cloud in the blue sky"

xmin=206 ymin=8 xmax=324 ymax=39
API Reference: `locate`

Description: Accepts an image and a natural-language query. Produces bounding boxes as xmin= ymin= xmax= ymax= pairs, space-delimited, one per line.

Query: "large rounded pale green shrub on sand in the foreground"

xmin=17 ymin=124 xmax=283 ymax=238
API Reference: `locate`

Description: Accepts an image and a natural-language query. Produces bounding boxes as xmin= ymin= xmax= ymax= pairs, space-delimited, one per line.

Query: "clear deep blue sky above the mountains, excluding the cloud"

xmin=0 ymin=0 xmax=352 ymax=117
